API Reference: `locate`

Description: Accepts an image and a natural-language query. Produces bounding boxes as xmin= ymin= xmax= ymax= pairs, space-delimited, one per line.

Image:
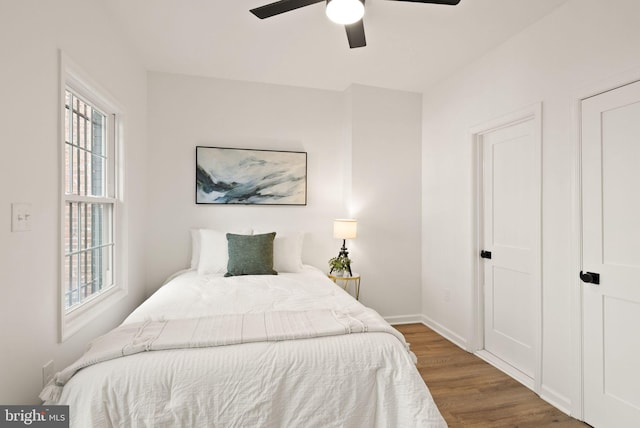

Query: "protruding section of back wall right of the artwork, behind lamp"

xmin=347 ymin=85 xmax=422 ymax=323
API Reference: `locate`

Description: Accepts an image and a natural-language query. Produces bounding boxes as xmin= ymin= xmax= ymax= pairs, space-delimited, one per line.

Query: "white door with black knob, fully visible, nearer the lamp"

xmin=482 ymin=119 xmax=540 ymax=390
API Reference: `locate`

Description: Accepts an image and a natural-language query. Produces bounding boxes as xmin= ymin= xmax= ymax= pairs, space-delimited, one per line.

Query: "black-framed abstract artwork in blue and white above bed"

xmin=196 ymin=146 xmax=307 ymax=205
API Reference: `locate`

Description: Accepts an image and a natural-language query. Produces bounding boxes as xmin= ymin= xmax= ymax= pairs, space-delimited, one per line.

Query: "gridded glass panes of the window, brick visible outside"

xmin=64 ymin=89 xmax=115 ymax=310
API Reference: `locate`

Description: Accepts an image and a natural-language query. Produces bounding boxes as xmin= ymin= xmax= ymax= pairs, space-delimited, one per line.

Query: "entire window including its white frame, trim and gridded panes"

xmin=60 ymin=57 xmax=126 ymax=340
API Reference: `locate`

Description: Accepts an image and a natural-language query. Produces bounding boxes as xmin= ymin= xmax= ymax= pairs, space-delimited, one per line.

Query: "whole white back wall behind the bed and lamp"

xmin=146 ymin=73 xmax=421 ymax=316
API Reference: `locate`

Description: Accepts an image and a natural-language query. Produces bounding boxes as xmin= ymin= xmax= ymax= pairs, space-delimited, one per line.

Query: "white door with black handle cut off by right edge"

xmin=581 ymin=78 xmax=640 ymax=428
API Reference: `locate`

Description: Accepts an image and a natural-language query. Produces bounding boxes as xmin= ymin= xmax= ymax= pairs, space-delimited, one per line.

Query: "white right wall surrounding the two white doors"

xmin=422 ymin=0 xmax=640 ymax=410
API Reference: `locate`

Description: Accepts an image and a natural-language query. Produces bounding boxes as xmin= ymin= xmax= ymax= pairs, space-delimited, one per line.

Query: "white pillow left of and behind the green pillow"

xmin=191 ymin=228 xmax=253 ymax=275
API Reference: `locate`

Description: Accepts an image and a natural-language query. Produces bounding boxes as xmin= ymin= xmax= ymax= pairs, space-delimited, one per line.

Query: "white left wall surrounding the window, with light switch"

xmin=0 ymin=0 xmax=146 ymax=404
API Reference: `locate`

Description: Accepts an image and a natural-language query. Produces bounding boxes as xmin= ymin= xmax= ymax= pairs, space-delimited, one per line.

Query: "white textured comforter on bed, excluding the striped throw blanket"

xmin=52 ymin=268 xmax=446 ymax=428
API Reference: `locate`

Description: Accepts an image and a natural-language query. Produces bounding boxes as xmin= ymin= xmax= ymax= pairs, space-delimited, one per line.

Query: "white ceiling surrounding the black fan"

xmin=103 ymin=0 xmax=568 ymax=92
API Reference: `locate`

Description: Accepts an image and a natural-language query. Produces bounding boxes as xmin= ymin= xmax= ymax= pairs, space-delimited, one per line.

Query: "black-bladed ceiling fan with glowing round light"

xmin=251 ymin=0 xmax=460 ymax=49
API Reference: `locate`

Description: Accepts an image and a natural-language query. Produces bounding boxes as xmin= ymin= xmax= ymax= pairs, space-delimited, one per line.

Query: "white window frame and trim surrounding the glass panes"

xmin=57 ymin=51 xmax=128 ymax=342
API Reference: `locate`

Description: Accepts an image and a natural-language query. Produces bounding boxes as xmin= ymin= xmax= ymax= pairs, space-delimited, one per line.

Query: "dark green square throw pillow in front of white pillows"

xmin=224 ymin=232 xmax=278 ymax=276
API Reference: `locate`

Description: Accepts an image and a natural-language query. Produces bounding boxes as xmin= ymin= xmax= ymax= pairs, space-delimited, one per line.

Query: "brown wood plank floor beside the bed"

xmin=395 ymin=324 xmax=589 ymax=428
